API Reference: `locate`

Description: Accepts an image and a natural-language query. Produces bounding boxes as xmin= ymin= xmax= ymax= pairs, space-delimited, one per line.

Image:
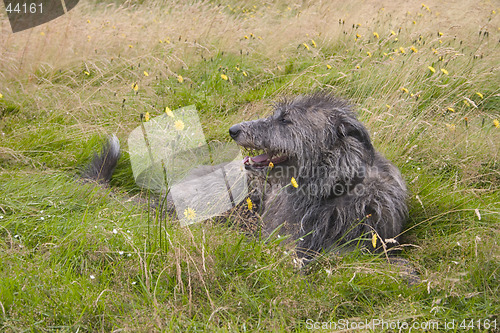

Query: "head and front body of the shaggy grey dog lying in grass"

xmin=229 ymin=93 xmax=407 ymax=256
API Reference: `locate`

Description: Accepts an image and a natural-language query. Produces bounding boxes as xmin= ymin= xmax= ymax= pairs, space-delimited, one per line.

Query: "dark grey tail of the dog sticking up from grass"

xmin=82 ymin=134 xmax=120 ymax=184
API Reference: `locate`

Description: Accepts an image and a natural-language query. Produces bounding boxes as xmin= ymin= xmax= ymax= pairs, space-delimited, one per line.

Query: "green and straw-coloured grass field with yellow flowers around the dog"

xmin=0 ymin=0 xmax=500 ymax=332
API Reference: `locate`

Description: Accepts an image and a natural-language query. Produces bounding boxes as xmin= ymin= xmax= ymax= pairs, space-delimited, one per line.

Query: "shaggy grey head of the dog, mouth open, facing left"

xmin=229 ymin=93 xmax=375 ymax=195
